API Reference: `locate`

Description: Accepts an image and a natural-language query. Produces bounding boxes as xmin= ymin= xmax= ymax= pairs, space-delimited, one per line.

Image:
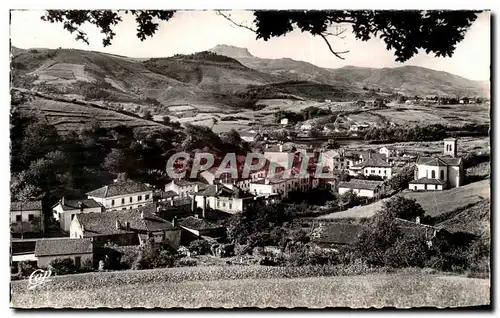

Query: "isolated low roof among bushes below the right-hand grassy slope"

xmin=311 ymin=223 xmax=364 ymax=244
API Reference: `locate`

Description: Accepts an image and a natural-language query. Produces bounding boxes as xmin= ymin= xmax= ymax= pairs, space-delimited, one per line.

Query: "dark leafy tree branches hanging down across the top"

xmin=42 ymin=10 xmax=480 ymax=62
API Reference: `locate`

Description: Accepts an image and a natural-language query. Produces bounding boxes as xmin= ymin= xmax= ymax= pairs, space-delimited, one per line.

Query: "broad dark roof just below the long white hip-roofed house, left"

xmin=76 ymin=204 xmax=175 ymax=237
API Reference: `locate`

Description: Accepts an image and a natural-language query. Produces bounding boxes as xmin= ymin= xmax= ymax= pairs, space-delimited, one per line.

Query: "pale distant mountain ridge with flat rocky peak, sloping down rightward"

xmin=210 ymin=45 xmax=489 ymax=97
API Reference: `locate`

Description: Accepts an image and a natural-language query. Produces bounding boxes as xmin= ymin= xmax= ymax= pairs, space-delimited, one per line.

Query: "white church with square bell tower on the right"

xmin=408 ymin=138 xmax=464 ymax=191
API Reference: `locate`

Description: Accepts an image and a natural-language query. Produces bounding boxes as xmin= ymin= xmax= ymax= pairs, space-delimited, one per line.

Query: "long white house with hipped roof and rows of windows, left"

xmin=87 ymin=180 xmax=153 ymax=211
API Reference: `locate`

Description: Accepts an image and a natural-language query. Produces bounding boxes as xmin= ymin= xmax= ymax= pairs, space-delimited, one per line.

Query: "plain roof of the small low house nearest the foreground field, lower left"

xmin=35 ymin=238 xmax=92 ymax=257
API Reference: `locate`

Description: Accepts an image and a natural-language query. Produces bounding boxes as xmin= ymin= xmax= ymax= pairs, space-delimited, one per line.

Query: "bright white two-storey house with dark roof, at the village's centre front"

xmin=193 ymin=184 xmax=254 ymax=214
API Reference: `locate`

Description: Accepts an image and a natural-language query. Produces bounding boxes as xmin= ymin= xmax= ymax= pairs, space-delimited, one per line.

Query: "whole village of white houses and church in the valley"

xmin=10 ymin=125 xmax=478 ymax=272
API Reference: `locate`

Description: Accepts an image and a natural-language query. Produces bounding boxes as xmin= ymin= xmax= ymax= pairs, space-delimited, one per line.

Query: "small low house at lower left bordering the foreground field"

xmin=35 ymin=238 xmax=94 ymax=268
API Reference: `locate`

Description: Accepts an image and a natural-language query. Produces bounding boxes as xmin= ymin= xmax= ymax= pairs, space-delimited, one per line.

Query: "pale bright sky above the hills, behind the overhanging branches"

xmin=10 ymin=10 xmax=491 ymax=81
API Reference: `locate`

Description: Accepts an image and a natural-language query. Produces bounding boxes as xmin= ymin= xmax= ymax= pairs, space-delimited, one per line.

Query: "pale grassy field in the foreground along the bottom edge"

xmin=11 ymin=266 xmax=490 ymax=308
